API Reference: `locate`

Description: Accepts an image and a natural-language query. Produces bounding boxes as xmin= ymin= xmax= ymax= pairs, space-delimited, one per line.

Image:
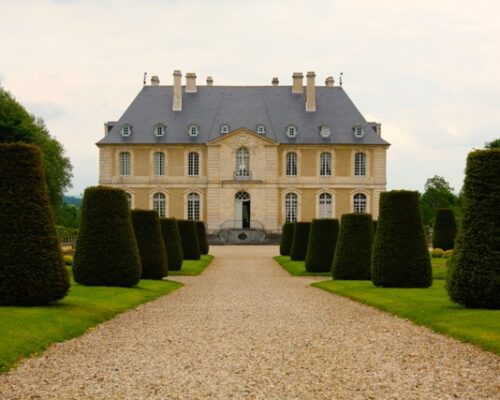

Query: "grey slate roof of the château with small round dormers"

xmin=98 ymin=86 xmax=388 ymax=145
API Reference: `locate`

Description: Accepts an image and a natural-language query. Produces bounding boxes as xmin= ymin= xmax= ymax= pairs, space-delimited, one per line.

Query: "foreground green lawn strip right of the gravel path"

xmin=313 ymin=280 xmax=500 ymax=354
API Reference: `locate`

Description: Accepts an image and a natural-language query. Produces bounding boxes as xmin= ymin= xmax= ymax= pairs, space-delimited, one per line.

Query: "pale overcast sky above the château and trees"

xmin=0 ymin=0 xmax=500 ymax=195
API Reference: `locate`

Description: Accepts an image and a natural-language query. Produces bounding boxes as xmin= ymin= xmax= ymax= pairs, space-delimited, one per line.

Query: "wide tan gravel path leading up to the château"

xmin=0 ymin=246 xmax=500 ymax=400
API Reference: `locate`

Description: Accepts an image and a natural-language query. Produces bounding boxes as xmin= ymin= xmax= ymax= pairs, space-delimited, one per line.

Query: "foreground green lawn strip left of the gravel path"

xmin=0 ymin=280 xmax=182 ymax=372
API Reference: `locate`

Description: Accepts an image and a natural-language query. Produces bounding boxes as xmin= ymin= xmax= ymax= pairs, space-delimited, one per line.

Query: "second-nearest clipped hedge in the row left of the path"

xmin=73 ymin=186 xmax=141 ymax=287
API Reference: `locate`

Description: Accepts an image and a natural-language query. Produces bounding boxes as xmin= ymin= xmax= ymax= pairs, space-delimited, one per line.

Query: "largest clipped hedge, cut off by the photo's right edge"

xmin=447 ymin=149 xmax=500 ymax=309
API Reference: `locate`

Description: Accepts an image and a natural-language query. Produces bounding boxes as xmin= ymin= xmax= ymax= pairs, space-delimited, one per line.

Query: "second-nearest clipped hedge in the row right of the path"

xmin=371 ymin=190 xmax=432 ymax=288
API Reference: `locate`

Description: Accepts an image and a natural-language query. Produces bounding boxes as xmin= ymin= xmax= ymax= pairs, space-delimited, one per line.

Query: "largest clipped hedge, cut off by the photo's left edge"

xmin=0 ymin=144 xmax=69 ymax=305
